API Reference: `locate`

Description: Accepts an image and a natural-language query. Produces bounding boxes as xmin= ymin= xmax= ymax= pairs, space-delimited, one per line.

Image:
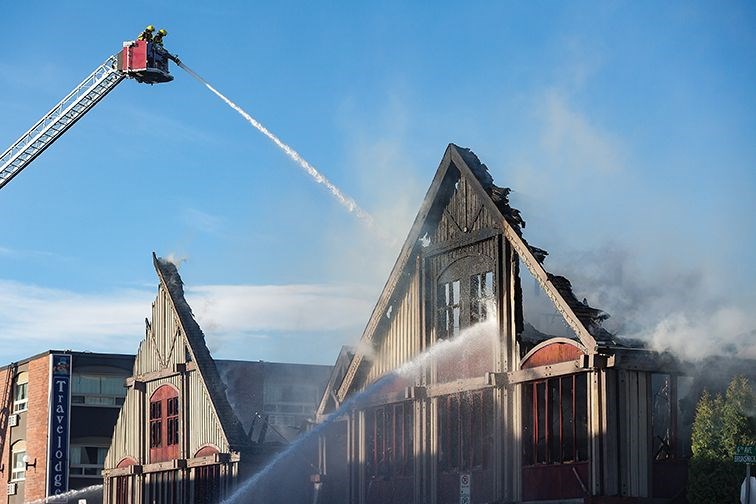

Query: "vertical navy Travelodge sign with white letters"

xmin=47 ymin=354 xmax=71 ymax=496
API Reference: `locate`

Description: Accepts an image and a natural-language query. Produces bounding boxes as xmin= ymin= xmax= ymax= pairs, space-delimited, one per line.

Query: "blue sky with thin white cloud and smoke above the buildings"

xmin=0 ymin=1 xmax=756 ymax=363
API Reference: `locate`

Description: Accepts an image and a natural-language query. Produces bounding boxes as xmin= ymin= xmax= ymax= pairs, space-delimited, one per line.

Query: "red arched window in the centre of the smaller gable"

xmin=149 ymin=385 xmax=179 ymax=462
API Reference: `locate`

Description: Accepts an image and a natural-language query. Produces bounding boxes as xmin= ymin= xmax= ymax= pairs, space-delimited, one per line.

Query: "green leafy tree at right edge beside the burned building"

xmin=688 ymin=376 xmax=756 ymax=504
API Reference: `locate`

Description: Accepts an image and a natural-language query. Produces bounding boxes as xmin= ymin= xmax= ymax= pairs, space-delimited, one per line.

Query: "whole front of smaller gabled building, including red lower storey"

xmin=103 ymin=256 xmax=256 ymax=504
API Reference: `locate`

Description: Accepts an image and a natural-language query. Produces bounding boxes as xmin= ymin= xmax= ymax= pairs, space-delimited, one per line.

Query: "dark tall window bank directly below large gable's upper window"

xmin=438 ymin=391 xmax=493 ymax=471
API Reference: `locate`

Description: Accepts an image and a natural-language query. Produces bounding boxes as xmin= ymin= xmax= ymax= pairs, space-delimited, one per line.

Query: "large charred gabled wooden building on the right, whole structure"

xmin=313 ymin=145 xmax=692 ymax=504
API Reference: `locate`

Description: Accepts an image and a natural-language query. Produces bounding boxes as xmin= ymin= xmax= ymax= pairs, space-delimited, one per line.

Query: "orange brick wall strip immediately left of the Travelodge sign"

xmin=24 ymin=355 xmax=50 ymax=500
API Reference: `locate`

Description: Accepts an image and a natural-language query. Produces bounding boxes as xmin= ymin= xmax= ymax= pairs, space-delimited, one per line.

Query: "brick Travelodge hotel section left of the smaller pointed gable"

xmin=0 ymin=350 xmax=134 ymax=504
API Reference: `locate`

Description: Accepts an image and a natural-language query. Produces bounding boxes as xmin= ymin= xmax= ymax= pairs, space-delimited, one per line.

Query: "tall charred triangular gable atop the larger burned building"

xmin=336 ymin=144 xmax=611 ymax=401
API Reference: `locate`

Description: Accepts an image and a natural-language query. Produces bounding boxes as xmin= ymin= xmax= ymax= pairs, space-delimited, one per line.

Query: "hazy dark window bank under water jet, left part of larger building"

xmin=365 ymin=403 xmax=414 ymax=478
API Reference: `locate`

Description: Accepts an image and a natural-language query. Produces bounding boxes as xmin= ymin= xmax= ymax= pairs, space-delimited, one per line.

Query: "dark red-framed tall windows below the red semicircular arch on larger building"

xmin=522 ymin=373 xmax=588 ymax=466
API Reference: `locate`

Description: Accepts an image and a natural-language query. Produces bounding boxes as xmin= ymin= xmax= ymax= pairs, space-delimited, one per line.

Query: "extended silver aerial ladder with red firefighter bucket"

xmin=0 ymin=40 xmax=180 ymax=189
